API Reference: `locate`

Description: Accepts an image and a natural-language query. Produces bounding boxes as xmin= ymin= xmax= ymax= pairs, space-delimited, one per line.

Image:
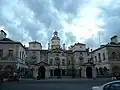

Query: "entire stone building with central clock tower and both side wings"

xmin=0 ymin=30 xmax=120 ymax=78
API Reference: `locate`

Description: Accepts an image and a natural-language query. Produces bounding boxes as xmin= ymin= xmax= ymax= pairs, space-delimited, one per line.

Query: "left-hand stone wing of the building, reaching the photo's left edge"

xmin=0 ymin=30 xmax=27 ymax=74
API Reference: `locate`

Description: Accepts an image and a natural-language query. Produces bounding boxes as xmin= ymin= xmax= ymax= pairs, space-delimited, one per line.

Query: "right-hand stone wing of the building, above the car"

xmin=92 ymin=35 xmax=120 ymax=76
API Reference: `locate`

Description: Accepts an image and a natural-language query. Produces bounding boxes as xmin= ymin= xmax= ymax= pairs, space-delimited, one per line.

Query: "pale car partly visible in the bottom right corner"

xmin=91 ymin=80 xmax=120 ymax=90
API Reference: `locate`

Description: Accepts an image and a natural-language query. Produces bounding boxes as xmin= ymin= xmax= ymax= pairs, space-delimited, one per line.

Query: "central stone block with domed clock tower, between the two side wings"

xmin=27 ymin=31 xmax=96 ymax=78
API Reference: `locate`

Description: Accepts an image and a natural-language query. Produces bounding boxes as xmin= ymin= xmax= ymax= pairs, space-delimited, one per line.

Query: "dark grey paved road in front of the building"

xmin=0 ymin=80 xmax=111 ymax=90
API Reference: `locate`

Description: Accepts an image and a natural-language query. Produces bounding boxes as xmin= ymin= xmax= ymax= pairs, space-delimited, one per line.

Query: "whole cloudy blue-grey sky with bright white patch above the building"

xmin=0 ymin=0 xmax=120 ymax=48
